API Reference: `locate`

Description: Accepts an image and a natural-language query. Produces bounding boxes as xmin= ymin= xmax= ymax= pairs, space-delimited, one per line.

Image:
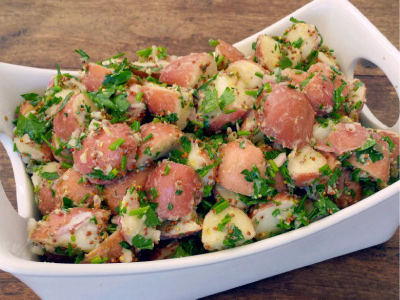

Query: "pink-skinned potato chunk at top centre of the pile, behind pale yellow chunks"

xmin=160 ymin=53 xmax=217 ymax=88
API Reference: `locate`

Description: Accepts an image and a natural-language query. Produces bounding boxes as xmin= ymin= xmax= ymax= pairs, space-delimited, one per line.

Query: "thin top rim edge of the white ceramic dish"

xmin=0 ymin=0 xmax=400 ymax=277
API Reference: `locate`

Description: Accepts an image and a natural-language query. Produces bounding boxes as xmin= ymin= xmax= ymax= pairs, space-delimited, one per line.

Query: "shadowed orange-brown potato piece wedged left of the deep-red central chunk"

xmin=103 ymin=169 xmax=150 ymax=215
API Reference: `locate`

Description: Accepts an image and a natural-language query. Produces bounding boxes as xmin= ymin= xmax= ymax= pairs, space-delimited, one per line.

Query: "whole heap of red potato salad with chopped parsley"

xmin=14 ymin=18 xmax=399 ymax=264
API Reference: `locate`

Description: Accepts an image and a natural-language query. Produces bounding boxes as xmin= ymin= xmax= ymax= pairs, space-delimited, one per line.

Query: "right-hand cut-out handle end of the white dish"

xmin=342 ymin=1 xmax=400 ymax=133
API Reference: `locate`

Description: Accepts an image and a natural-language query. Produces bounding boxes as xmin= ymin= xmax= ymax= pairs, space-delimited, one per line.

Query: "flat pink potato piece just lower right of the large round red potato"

xmin=314 ymin=123 xmax=370 ymax=155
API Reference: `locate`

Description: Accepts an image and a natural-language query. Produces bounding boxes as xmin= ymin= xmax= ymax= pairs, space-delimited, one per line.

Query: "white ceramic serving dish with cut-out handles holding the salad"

xmin=0 ymin=0 xmax=400 ymax=299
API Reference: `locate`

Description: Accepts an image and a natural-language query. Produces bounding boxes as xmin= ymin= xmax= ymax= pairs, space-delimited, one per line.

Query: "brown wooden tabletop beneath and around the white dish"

xmin=0 ymin=0 xmax=399 ymax=299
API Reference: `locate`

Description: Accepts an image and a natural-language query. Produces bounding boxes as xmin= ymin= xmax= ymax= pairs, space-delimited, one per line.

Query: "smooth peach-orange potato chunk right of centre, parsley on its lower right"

xmin=217 ymin=139 xmax=266 ymax=196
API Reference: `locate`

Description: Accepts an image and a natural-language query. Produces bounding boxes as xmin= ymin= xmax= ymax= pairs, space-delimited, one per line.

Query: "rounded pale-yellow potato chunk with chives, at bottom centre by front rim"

xmin=201 ymin=207 xmax=255 ymax=251
